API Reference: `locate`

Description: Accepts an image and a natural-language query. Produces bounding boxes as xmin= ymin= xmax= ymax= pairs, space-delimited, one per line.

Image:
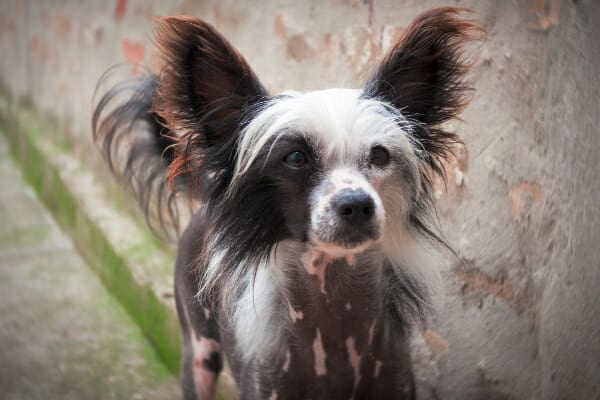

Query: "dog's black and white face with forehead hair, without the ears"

xmin=229 ymin=89 xmax=419 ymax=256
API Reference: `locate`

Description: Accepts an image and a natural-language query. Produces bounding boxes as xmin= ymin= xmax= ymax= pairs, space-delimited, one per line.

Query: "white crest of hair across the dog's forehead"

xmin=232 ymin=89 xmax=420 ymax=186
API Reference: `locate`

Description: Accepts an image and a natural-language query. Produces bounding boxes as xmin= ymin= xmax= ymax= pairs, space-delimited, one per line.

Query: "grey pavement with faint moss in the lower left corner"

xmin=0 ymin=135 xmax=179 ymax=400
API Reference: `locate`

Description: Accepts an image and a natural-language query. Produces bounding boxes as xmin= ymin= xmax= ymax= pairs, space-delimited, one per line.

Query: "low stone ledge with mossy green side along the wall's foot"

xmin=0 ymin=104 xmax=235 ymax=399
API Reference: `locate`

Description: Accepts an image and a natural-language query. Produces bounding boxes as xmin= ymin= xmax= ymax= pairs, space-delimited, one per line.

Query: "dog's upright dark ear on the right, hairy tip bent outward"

xmin=365 ymin=7 xmax=483 ymax=173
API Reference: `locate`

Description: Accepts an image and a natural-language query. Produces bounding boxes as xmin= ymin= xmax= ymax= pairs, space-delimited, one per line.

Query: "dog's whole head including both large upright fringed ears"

xmin=154 ymin=8 xmax=480 ymax=260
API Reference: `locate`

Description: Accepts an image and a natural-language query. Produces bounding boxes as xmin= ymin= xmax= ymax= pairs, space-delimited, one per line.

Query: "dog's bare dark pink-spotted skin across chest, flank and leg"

xmin=176 ymin=211 xmax=414 ymax=400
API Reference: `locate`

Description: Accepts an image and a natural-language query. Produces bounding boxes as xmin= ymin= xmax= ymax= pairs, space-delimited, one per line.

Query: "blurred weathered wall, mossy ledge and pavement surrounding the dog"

xmin=0 ymin=0 xmax=600 ymax=399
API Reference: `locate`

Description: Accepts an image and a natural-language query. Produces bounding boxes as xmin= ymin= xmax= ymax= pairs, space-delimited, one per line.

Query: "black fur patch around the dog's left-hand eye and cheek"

xmin=202 ymin=135 xmax=320 ymax=295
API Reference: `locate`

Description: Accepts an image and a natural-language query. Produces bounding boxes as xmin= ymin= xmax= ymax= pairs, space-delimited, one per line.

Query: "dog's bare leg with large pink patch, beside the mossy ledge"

xmin=175 ymin=250 xmax=223 ymax=400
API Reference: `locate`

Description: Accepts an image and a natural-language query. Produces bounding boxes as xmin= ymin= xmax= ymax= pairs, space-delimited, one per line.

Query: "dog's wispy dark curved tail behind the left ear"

xmin=92 ymin=65 xmax=190 ymax=240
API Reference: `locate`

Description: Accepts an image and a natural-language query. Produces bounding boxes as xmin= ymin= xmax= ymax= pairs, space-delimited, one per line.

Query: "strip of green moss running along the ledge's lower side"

xmin=4 ymin=106 xmax=180 ymax=372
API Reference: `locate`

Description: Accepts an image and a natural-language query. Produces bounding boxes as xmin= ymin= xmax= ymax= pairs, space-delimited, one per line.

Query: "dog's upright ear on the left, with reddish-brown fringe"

xmin=153 ymin=16 xmax=267 ymax=188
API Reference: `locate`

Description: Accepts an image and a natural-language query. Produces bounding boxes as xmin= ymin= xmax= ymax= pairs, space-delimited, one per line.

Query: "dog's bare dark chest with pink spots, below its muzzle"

xmin=255 ymin=253 xmax=414 ymax=399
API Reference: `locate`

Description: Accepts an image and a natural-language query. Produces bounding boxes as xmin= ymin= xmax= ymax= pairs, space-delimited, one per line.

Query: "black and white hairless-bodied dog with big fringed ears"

xmin=93 ymin=8 xmax=482 ymax=400
